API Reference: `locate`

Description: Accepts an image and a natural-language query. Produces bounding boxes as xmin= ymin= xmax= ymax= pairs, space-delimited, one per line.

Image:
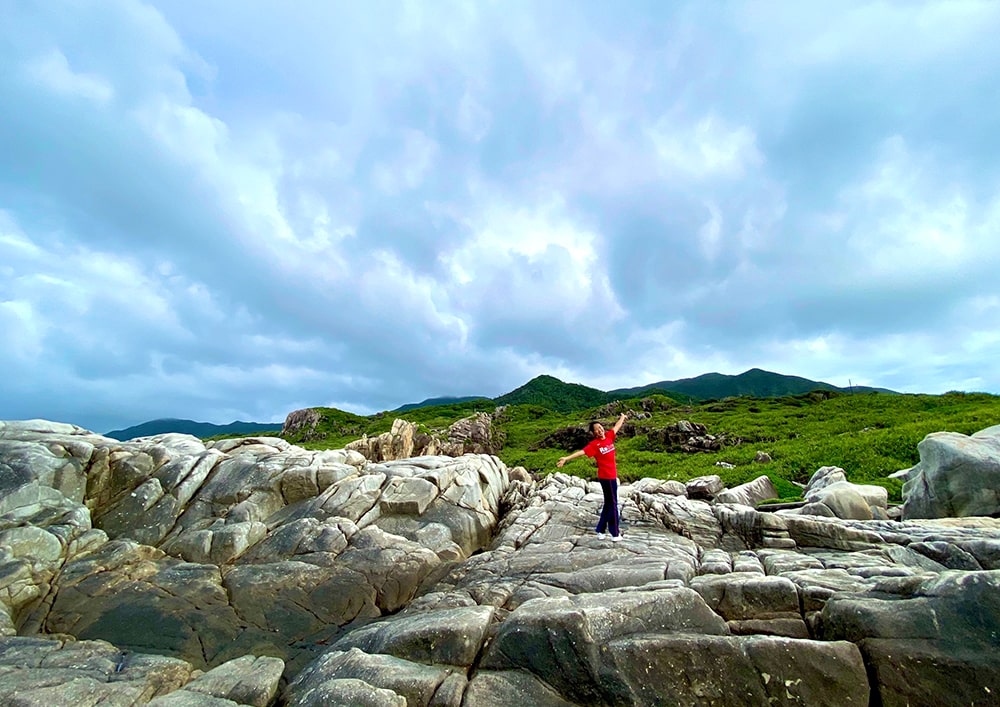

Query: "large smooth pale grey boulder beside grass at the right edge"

xmin=894 ymin=425 xmax=1000 ymax=519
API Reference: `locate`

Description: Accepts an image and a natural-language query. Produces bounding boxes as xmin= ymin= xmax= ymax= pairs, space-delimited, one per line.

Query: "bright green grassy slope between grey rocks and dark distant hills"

xmin=205 ymin=391 xmax=1000 ymax=501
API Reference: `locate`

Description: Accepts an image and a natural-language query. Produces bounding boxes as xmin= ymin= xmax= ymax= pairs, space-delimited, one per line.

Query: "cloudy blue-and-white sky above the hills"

xmin=0 ymin=0 xmax=1000 ymax=432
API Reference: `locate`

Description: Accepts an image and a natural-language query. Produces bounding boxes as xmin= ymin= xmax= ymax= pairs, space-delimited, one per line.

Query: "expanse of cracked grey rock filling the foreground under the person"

xmin=0 ymin=420 xmax=1000 ymax=707
